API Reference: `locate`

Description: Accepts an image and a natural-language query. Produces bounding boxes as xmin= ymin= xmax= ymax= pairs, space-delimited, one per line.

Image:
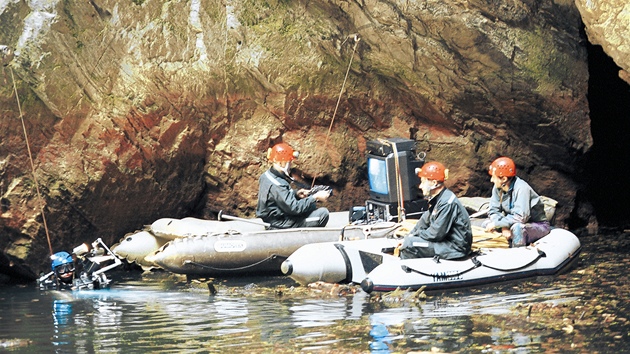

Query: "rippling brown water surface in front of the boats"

xmin=0 ymin=231 xmax=630 ymax=353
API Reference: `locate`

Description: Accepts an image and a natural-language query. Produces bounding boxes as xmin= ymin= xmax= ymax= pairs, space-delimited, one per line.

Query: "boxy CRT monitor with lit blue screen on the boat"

xmin=367 ymin=151 xmax=423 ymax=203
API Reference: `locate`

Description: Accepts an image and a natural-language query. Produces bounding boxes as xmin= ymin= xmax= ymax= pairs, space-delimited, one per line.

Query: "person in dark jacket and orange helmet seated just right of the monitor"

xmin=399 ymin=162 xmax=472 ymax=259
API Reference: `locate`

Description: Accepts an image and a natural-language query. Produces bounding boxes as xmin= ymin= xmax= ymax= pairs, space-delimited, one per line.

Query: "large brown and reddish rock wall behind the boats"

xmin=0 ymin=0 xmax=593 ymax=278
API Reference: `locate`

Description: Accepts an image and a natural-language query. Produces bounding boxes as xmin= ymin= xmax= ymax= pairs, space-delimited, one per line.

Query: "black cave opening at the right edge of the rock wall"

xmin=581 ymin=43 xmax=630 ymax=228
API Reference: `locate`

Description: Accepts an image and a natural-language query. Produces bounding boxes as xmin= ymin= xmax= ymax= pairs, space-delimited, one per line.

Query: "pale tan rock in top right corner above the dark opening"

xmin=575 ymin=0 xmax=630 ymax=84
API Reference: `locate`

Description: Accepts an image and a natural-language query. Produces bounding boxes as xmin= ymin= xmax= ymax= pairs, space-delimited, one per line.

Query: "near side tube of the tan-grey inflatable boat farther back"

xmin=145 ymin=218 xmax=398 ymax=277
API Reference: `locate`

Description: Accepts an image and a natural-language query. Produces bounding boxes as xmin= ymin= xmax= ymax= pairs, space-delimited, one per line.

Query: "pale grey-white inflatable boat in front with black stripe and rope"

xmin=281 ymin=228 xmax=581 ymax=293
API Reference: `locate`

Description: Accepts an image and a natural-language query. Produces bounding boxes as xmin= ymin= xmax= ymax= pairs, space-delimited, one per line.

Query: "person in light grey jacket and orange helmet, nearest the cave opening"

xmin=482 ymin=157 xmax=551 ymax=247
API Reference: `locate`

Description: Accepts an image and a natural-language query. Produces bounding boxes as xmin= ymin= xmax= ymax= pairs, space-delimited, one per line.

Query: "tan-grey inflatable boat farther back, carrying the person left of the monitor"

xmin=112 ymin=212 xmax=400 ymax=277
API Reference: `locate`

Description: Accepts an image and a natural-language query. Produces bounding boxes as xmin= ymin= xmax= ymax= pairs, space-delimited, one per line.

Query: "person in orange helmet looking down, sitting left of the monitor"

xmin=256 ymin=143 xmax=330 ymax=229
